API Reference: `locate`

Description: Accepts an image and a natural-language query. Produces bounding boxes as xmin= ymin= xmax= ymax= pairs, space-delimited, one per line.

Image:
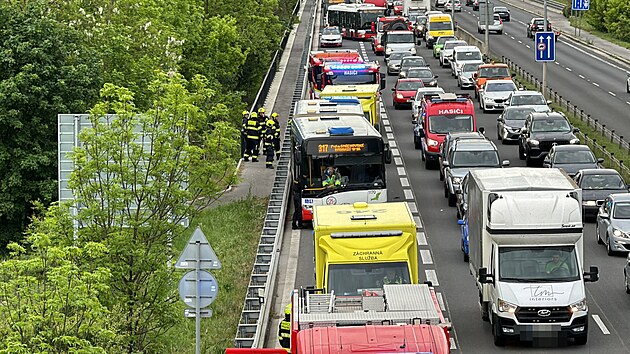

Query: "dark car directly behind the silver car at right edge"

xmin=573 ymin=168 xmax=628 ymax=219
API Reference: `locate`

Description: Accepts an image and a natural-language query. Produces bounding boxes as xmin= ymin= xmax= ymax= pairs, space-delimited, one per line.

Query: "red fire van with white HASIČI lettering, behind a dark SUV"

xmin=420 ymin=93 xmax=477 ymax=168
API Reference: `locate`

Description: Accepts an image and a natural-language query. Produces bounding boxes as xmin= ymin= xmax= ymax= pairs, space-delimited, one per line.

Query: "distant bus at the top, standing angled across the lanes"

xmin=328 ymin=4 xmax=387 ymax=40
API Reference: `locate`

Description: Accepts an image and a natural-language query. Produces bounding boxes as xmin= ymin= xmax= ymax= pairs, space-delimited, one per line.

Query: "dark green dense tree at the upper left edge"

xmin=0 ymin=1 xmax=102 ymax=247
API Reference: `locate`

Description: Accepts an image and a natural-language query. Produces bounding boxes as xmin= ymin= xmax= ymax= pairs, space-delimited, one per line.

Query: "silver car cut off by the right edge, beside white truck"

xmin=595 ymin=193 xmax=630 ymax=256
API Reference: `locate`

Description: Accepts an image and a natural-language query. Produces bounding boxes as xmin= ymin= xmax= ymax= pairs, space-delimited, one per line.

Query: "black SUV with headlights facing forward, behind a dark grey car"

xmin=518 ymin=112 xmax=580 ymax=166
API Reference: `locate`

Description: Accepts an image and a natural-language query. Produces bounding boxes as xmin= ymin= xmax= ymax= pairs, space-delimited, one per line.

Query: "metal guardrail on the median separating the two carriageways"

xmin=501 ymin=56 xmax=630 ymax=181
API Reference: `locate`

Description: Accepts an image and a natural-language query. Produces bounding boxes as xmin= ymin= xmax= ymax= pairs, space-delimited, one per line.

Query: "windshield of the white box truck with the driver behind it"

xmin=499 ymin=246 xmax=580 ymax=283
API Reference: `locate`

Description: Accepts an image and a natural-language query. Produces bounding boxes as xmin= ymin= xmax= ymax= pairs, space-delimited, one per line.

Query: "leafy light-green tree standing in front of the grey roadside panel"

xmin=70 ymin=73 xmax=239 ymax=353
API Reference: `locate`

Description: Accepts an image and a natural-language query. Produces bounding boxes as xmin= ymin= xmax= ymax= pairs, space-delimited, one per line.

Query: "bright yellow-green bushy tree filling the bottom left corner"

xmin=0 ymin=205 xmax=114 ymax=354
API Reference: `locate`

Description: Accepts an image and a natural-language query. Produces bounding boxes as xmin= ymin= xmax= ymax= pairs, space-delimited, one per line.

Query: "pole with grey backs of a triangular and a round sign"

xmin=175 ymin=226 xmax=221 ymax=354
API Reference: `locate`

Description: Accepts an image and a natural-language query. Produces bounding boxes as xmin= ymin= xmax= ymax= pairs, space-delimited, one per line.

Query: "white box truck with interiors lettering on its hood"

xmin=468 ymin=168 xmax=598 ymax=346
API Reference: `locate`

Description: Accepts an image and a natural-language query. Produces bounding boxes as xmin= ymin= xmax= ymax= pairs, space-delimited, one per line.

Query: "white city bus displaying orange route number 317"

xmin=291 ymin=114 xmax=392 ymax=221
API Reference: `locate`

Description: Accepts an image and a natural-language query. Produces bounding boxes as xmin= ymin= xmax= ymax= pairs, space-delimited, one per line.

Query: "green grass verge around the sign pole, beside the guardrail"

xmin=166 ymin=198 xmax=268 ymax=354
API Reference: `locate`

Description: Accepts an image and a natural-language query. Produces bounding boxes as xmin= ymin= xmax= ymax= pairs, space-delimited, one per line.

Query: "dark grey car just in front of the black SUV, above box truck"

xmin=543 ymin=144 xmax=604 ymax=177
